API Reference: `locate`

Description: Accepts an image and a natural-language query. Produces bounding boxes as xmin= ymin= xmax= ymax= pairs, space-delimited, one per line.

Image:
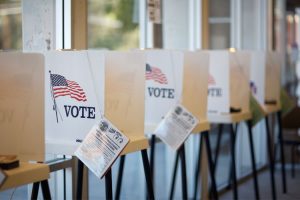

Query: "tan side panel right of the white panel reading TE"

xmin=229 ymin=51 xmax=250 ymax=112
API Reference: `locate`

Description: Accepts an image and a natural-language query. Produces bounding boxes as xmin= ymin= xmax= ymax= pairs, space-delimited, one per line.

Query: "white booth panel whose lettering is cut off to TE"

xmin=207 ymin=51 xmax=230 ymax=114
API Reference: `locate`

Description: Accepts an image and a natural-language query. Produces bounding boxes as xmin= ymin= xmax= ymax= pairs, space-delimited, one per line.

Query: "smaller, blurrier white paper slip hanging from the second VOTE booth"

xmin=154 ymin=104 xmax=199 ymax=150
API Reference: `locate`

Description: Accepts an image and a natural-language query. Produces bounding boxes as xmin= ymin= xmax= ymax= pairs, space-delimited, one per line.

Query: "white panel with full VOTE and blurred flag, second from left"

xmin=142 ymin=50 xmax=183 ymax=134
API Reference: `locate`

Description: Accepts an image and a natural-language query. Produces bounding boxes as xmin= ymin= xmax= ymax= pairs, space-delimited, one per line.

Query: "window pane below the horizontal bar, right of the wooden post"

xmin=209 ymin=23 xmax=230 ymax=49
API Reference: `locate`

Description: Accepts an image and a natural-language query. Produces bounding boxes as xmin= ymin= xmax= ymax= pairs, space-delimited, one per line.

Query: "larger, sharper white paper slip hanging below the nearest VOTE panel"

xmin=75 ymin=118 xmax=129 ymax=178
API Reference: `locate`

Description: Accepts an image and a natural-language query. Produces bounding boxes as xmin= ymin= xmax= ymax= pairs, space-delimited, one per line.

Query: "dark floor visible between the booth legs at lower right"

xmin=220 ymin=164 xmax=300 ymax=200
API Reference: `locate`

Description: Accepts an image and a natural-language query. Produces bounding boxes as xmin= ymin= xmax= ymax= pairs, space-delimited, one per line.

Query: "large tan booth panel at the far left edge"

xmin=0 ymin=52 xmax=45 ymax=161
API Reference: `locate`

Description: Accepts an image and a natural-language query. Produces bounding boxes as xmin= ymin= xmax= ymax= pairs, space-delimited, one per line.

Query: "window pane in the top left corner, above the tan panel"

xmin=0 ymin=0 xmax=22 ymax=50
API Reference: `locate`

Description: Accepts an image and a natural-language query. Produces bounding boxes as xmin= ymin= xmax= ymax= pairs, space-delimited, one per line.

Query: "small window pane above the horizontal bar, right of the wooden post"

xmin=209 ymin=0 xmax=230 ymax=17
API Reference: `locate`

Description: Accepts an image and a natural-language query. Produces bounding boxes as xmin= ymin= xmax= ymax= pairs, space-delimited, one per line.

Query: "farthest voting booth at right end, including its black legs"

xmin=250 ymin=51 xmax=287 ymax=198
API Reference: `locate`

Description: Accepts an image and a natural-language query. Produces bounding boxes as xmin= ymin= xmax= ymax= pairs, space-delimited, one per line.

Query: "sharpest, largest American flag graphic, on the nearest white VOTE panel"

xmin=50 ymin=74 xmax=87 ymax=101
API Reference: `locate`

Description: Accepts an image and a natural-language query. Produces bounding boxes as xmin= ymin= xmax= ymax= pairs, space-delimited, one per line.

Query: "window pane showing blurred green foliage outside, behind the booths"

xmin=88 ymin=0 xmax=139 ymax=50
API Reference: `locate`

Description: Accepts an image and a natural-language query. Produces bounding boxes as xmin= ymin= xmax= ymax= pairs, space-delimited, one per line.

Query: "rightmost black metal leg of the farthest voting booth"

xmin=277 ymin=111 xmax=287 ymax=193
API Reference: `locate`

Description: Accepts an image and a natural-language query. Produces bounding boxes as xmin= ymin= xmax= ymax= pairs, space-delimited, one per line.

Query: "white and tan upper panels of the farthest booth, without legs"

xmin=250 ymin=51 xmax=281 ymax=105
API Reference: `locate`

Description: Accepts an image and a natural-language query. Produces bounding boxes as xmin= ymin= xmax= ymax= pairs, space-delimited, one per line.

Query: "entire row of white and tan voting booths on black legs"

xmin=0 ymin=50 xmax=284 ymax=199
